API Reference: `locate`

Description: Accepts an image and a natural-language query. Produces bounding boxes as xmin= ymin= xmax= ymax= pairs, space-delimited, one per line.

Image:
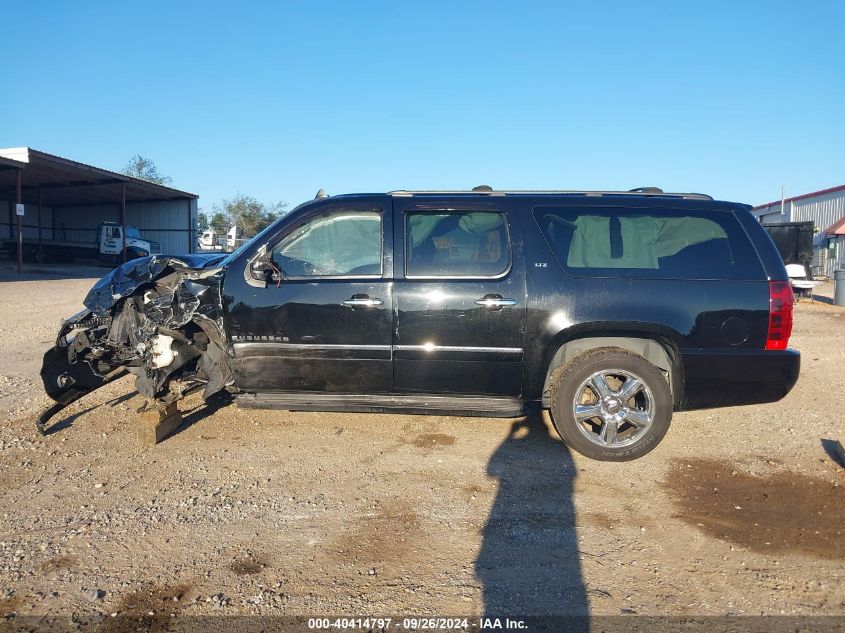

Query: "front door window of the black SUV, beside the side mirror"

xmin=272 ymin=210 xmax=382 ymax=277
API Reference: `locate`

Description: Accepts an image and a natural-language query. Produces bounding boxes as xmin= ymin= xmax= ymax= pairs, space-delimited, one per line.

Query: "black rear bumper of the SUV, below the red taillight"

xmin=676 ymin=349 xmax=801 ymax=411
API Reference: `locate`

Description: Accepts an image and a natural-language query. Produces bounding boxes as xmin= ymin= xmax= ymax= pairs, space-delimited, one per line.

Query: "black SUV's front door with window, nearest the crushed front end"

xmin=224 ymin=199 xmax=392 ymax=393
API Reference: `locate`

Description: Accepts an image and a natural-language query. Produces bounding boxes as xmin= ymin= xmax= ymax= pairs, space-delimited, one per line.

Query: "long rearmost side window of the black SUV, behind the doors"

xmin=534 ymin=207 xmax=762 ymax=279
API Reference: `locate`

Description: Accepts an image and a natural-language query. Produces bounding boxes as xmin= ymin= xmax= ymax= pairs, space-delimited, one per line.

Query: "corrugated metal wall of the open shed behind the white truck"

xmin=55 ymin=200 xmax=197 ymax=255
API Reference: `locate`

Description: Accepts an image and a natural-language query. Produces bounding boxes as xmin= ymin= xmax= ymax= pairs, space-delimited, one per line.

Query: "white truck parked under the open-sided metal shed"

xmin=0 ymin=222 xmax=161 ymax=266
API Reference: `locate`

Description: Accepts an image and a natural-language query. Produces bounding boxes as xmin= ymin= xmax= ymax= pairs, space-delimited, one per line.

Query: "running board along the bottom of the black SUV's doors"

xmin=236 ymin=393 xmax=526 ymax=418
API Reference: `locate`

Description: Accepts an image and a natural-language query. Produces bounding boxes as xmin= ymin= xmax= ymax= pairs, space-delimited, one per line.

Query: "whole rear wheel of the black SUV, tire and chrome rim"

xmin=551 ymin=348 xmax=672 ymax=462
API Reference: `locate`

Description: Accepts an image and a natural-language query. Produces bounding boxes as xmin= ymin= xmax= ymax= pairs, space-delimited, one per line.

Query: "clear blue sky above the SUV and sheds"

xmin=0 ymin=1 xmax=845 ymax=207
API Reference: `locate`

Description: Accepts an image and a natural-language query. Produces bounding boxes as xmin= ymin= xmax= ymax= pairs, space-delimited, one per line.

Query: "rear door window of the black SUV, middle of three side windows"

xmin=405 ymin=211 xmax=510 ymax=277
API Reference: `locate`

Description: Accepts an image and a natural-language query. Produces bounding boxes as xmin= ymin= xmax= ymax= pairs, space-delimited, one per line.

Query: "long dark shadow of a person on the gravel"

xmin=475 ymin=411 xmax=589 ymax=631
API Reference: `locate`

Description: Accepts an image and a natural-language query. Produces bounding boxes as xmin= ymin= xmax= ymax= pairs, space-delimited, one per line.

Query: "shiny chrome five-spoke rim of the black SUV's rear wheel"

xmin=572 ymin=369 xmax=655 ymax=448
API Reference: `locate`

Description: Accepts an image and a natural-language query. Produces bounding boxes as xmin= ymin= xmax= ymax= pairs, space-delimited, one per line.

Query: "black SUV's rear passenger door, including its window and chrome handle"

xmin=393 ymin=196 xmax=526 ymax=396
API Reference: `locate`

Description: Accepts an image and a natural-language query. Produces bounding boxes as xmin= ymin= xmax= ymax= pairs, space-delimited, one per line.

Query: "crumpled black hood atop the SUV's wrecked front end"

xmin=83 ymin=253 xmax=226 ymax=316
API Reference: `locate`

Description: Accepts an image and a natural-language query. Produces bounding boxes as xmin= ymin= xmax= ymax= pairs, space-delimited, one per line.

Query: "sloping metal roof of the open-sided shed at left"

xmin=0 ymin=147 xmax=197 ymax=207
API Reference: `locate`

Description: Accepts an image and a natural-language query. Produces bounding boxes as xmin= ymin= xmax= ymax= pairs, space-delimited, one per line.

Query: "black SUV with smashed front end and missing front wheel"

xmin=39 ymin=187 xmax=800 ymax=460
